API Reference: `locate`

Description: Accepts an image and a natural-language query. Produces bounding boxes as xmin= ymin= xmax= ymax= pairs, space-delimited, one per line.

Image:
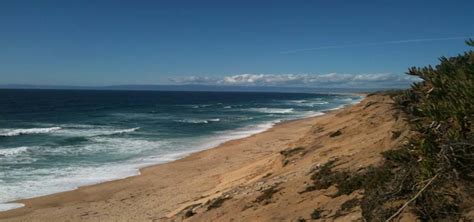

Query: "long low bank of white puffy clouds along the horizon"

xmin=171 ymin=73 xmax=418 ymax=88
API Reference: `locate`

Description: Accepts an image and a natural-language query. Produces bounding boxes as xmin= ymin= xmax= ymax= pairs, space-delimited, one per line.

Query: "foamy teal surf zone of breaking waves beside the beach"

xmin=0 ymin=93 xmax=366 ymax=211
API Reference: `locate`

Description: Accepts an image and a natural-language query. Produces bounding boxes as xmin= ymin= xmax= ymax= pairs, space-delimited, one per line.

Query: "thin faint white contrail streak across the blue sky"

xmin=280 ymin=36 xmax=471 ymax=54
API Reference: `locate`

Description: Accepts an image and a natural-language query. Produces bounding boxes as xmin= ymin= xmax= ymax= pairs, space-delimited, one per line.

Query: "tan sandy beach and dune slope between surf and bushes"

xmin=0 ymin=95 xmax=407 ymax=221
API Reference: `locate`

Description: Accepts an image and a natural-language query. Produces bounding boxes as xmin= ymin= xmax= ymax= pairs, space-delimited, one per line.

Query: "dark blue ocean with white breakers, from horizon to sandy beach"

xmin=0 ymin=90 xmax=361 ymax=210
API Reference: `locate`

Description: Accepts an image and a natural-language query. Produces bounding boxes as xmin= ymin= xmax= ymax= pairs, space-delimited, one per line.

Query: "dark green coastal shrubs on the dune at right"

xmin=360 ymin=40 xmax=474 ymax=221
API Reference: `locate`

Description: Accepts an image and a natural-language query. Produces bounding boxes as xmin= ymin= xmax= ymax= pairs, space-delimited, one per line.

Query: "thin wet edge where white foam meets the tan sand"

xmin=0 ymin=94 xmax=366 ymax=219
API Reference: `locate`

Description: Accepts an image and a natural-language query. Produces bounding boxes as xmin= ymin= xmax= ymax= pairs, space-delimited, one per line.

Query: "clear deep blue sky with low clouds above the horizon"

xmin=0 ymin=0 xmax=474 ymax=87
